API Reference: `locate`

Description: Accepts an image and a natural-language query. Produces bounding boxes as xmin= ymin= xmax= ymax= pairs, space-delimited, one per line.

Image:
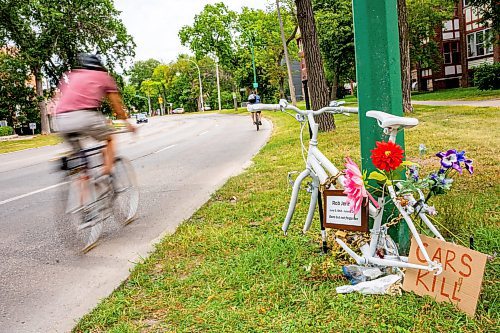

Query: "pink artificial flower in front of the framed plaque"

xmin=342 ymin=157 xmax=379 ymax=214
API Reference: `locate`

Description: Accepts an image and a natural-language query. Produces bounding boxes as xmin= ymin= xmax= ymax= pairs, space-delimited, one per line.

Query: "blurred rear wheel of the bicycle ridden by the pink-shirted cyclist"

xmin=56 ymin=174 xmax=107 ymax=253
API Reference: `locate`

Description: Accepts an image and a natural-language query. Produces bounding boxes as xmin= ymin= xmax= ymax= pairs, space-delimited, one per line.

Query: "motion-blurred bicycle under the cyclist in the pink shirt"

xmin=57 ymin=132 xmax=139 ymax=253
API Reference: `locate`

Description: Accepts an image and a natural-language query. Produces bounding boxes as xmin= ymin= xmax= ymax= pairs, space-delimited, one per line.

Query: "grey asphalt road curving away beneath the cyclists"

xmin=0 ymin=114 xmax=272 ymax=333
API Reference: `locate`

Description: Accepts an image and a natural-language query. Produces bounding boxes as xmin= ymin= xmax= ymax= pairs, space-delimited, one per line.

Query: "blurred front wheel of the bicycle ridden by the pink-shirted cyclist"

xmin=112 ymin=157 xmax=139 ymax=225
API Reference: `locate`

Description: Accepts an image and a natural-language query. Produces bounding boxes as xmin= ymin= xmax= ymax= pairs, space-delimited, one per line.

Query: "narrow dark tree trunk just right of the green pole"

xmin=398 ymin=0 xmax=413 ymax=113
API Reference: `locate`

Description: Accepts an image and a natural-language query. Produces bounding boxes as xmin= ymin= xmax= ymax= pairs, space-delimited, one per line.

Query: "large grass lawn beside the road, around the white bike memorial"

xmin=74 ymin=107 xmax=500 ymax=332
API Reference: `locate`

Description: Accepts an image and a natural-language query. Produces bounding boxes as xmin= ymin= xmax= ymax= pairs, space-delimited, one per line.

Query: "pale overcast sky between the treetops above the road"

xmin=115 ymin=0 xmax=272 ymax=62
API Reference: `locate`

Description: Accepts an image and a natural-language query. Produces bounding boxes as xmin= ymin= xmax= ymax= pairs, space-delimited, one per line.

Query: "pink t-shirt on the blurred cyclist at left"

xmin=56 ymin=69 xmax=118 ymax=113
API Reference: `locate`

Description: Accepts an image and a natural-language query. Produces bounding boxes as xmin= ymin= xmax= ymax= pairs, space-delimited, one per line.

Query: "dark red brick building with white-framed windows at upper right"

xmin=412 ymin=0 xmax=500 ymax=90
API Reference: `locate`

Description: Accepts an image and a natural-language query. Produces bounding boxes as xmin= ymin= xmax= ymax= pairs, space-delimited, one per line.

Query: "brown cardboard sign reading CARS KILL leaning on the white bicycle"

xmin=403 ymin=235 xmax=487 ymax=316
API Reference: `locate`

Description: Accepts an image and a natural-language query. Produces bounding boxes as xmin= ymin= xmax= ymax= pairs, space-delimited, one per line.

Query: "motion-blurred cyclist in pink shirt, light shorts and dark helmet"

xmin=56 ymin=53 xmax=136 ymax=174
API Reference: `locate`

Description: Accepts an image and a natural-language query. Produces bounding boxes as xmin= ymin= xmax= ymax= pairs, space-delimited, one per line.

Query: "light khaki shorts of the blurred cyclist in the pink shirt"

xmin=56 ymin=110 xmax=114 ymax=141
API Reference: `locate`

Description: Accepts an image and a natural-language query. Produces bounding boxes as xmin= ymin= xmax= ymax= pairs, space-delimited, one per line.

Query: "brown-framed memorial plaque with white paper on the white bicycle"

xmin=323 ymin=190 xmax=368 ymax=232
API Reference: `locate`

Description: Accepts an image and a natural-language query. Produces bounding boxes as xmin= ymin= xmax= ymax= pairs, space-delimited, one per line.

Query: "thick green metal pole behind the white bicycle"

xmin=353 ymin=0 xmax=410 ymax=253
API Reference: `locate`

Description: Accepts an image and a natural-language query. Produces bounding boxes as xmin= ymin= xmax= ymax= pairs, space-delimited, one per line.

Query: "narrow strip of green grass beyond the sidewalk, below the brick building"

xmin=411 ymin=87 xmax=500 ymax=101
